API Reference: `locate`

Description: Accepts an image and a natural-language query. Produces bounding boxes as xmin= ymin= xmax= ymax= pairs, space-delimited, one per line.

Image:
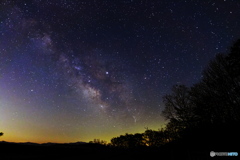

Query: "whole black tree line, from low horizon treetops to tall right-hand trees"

xmin=108 ymin=39 xmax=240 ymax=148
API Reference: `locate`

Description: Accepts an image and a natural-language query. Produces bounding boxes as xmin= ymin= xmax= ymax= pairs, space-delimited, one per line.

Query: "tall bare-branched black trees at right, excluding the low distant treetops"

xmin=163 ymin=40 xmax=240 ymax=130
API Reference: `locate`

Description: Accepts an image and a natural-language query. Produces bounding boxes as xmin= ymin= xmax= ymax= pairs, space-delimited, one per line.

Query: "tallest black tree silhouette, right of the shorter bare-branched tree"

xmin=191 ymin=40 xmax=240 ymax=125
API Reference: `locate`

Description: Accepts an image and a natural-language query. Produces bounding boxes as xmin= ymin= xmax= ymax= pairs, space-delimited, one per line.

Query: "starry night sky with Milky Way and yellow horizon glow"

xmin=0 ymin=0 xmax=240 ymax=143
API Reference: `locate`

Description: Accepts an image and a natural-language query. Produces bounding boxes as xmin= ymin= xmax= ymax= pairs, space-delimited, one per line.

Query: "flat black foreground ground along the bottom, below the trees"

xmin=0 ymin=142 xmax=239 ymax=160
